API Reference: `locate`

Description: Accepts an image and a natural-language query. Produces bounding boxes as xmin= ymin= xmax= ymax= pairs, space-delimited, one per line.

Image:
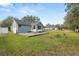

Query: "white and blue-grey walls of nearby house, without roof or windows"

xmin=11 ymin=20 xmax=44 ymax=33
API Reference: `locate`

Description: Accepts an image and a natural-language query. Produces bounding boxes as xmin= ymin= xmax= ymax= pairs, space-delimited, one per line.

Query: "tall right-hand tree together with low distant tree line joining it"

xmin=46 ymin=3 xmax=79 ymax=32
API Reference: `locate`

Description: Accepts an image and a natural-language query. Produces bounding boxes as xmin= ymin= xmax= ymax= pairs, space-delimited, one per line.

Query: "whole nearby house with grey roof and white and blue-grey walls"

xmin=11 ymin=19 xmax=44 ymax=33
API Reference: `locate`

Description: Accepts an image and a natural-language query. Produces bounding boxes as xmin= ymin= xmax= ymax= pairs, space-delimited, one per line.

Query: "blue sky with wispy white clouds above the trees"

xmin=0 ymin=3 xmax=66 ymax=25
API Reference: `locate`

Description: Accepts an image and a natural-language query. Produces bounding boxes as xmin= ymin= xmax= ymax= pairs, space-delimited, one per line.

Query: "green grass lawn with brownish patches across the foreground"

xmin=0 ymin=31 xmax=79 ymax=56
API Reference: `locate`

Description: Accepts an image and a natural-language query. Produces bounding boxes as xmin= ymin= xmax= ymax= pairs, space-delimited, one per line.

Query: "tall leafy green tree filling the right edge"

xmin=64 ymin=3 xmax=79 ymax=30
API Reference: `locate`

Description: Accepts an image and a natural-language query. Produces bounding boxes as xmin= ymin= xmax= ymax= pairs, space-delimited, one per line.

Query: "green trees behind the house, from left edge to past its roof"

xmin=0 ymin=15 xmax=40 ymax=27
